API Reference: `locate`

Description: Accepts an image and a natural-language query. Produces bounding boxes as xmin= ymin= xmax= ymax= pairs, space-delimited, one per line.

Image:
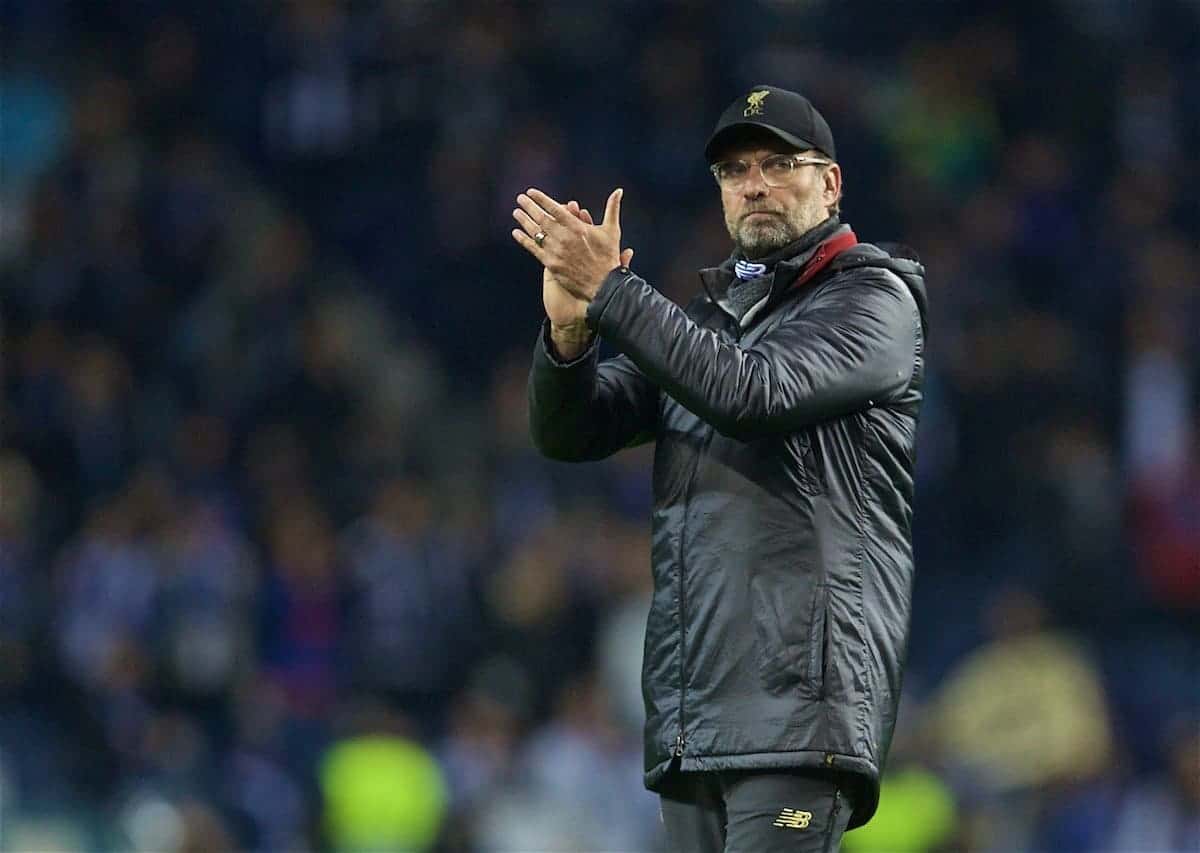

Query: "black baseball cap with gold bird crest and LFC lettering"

xmin=704 ymin=85 xmax=838 ymax=163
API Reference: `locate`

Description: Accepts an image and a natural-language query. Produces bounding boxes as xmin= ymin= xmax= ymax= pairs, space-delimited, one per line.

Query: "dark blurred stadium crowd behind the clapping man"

xmin=0 ymin=0 xmax=1200 ymax=853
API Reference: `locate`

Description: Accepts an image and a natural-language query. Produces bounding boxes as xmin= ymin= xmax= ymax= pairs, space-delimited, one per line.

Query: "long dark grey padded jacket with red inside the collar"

xmin=529 ymin=221 xmax=926 ymax=827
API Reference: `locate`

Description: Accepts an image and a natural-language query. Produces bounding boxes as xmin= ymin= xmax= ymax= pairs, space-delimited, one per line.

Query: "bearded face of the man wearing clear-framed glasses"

xmin=719 ymin=138 xmax=841 ymax=258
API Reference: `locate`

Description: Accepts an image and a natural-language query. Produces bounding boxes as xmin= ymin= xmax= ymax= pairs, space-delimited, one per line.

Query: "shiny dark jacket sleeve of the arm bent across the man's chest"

xmin=587 ymin=268 xmax=920 ymax=439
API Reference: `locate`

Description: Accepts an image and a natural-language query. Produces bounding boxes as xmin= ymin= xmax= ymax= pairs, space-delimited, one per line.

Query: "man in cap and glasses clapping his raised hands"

xmin=512 ymin=81 xmax=926 ymax=853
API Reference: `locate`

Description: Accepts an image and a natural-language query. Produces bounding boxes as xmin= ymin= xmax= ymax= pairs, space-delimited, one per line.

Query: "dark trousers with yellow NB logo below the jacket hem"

xmin=659 ymin=770 xmax=852 ymax=853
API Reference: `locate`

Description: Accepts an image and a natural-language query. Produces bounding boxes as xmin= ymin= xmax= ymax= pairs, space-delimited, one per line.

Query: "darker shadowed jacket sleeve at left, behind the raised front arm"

xmin=529 ymin=322 xmax=659 ymax=462
